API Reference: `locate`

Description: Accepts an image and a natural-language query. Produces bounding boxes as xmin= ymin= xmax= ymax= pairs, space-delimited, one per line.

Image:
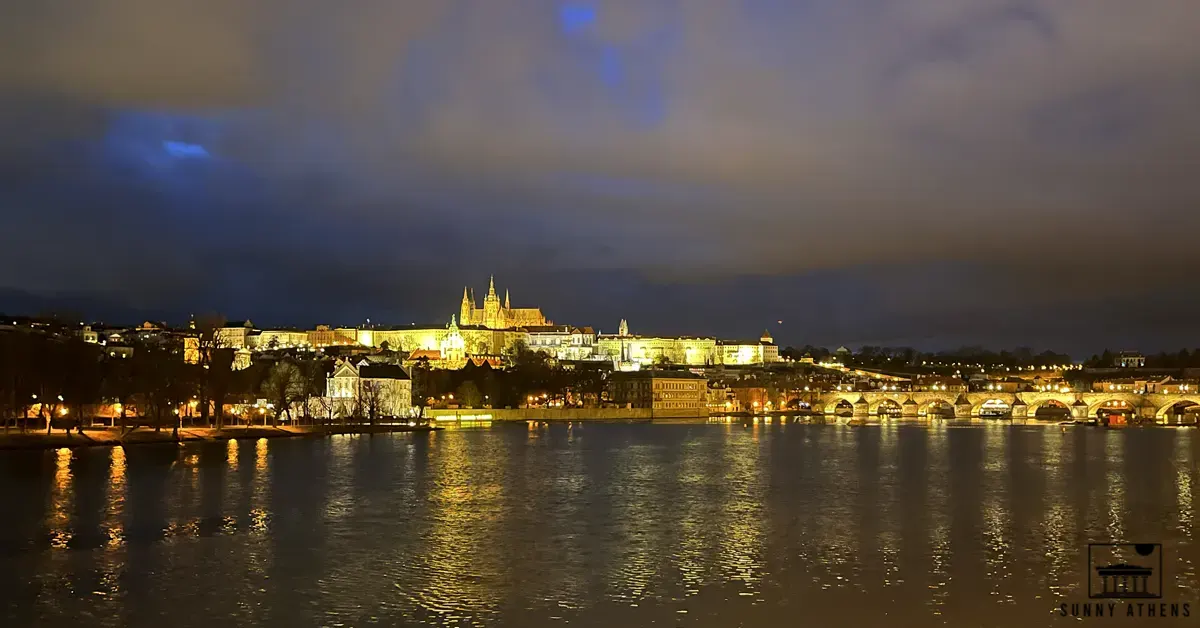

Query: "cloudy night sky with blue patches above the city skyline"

xmin=0 ymin=0 xmax=1200 ymax=353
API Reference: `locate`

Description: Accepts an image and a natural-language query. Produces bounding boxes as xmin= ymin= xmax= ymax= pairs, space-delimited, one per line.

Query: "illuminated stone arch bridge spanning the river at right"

xmin=799 ymin=390 xmax=1200 ymax=421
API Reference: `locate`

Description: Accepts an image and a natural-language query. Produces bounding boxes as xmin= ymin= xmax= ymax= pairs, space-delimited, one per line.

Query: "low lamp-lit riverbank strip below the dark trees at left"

xmin=0 ymin=425 xmax=440 ymax=450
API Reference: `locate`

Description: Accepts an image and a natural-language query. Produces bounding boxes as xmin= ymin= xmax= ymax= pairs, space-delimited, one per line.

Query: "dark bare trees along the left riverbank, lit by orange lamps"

xmin=0 ymin=325 xmax=328 ymax=436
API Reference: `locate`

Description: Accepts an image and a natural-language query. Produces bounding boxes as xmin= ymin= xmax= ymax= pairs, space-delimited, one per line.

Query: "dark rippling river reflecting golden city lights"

xmin=0 ymin=423 xmax=1200 ymax=628
